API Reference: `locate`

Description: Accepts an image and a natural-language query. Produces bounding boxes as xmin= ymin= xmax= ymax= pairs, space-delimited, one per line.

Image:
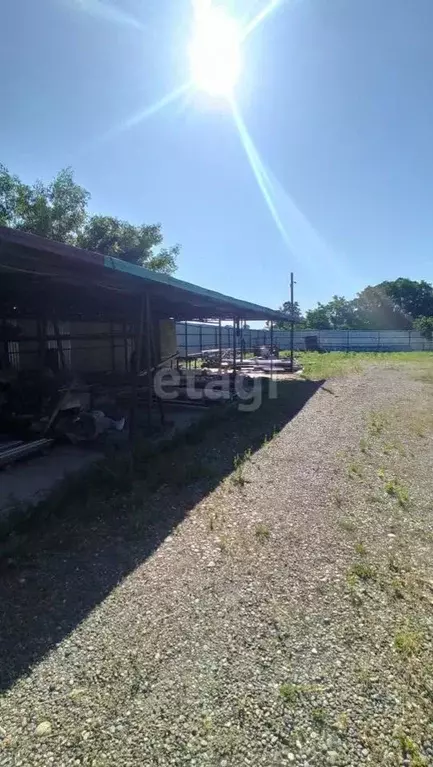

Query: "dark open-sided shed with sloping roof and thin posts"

xmin=0 ymin=227 xmax=287 ymax=450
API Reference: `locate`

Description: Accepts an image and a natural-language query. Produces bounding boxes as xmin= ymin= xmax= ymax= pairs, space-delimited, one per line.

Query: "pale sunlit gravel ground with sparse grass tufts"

xmin=0 ymin=366 xmax=433 ymax=767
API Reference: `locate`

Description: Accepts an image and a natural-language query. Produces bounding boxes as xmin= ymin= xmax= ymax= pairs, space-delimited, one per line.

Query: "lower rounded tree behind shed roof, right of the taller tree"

xmin=78 ymin=216 xmax=180 ymax=274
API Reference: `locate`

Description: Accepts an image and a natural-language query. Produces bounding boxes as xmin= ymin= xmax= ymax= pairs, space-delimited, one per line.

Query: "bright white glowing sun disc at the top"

xmin=189 ymin=0 xmax=241 ymax=96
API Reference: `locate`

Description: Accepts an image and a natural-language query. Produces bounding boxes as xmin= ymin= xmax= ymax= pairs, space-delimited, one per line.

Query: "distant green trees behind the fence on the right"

xmin=278 ymin=277 xmax=433 ymax=338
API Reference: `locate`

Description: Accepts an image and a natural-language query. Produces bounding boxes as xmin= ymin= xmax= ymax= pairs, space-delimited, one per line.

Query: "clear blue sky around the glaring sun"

xmin=0 ymin=0 xmax=433 ymax=309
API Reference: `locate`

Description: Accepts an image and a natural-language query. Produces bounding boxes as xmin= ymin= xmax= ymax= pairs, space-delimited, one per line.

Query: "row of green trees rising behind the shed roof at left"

xmin=0 ymin=164 xmax=180 ymax=274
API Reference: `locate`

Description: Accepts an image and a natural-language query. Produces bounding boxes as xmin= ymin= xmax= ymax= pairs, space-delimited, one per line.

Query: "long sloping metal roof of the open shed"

xmin=0 ymin=227 xmax=288 ymax=322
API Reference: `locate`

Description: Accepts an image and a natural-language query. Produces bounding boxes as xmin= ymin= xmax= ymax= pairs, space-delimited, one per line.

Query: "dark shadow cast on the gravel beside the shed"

xmin=0 ymin=380 xmax=323 ymax=691
